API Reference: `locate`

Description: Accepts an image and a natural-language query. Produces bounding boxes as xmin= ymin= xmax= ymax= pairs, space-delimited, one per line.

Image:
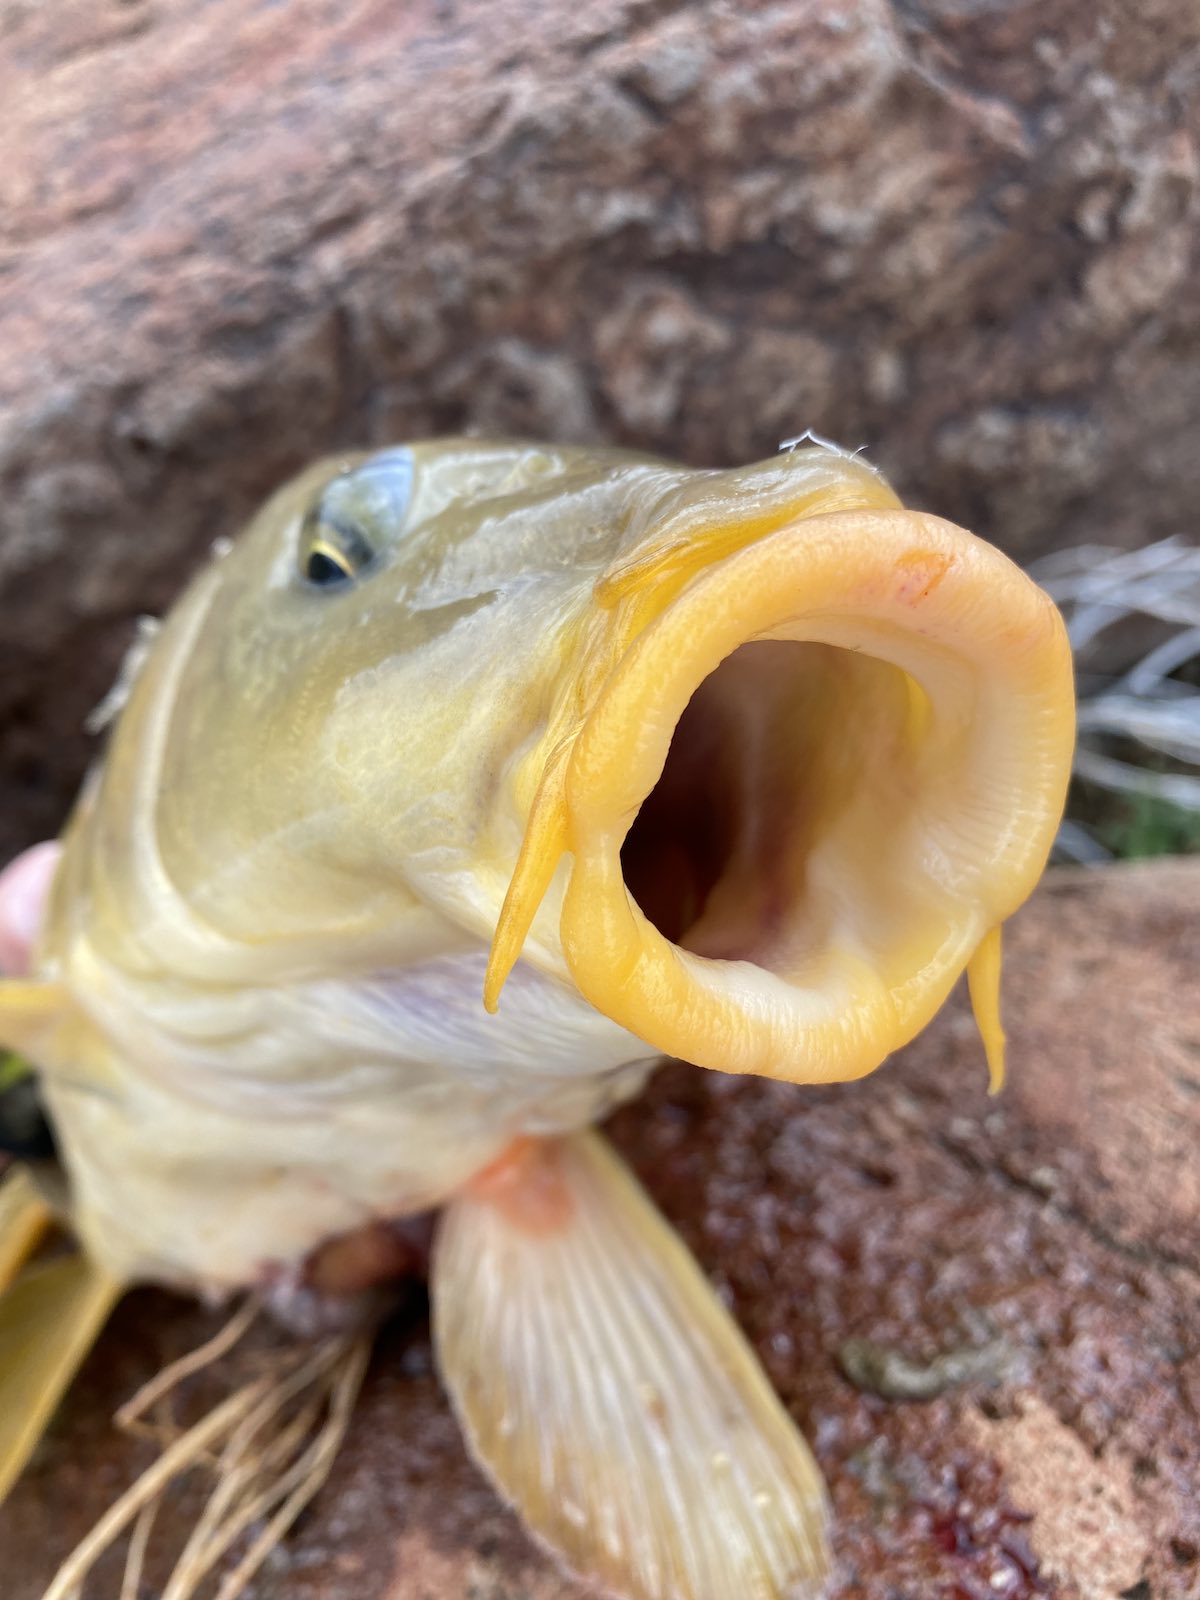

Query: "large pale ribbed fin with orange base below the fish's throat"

xmin=432 ymin=1134 xmax=829 ymax=1600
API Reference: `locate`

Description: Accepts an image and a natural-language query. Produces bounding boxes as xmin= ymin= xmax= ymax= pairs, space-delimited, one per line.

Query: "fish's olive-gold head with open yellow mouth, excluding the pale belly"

xmin=51 ymin=440 xmax=1074 ymax=1082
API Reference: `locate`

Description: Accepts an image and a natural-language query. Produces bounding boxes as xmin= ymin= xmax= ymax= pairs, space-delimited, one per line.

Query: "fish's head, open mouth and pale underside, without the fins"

xmin=0 ymin=442 xmax=1072 ymax=1290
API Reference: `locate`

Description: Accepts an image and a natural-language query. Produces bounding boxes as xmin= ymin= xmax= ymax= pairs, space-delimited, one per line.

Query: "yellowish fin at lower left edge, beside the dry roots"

xmin=0 ymin=1254 xmax=122 ymax=1501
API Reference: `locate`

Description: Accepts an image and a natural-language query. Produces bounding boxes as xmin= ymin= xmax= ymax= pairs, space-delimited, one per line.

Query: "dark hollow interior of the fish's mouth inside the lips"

xmin=621 ymin=640 xmax=928 ymax=981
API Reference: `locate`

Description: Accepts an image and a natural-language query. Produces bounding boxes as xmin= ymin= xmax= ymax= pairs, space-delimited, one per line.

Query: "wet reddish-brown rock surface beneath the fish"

xmin=0 ymin=862 xmax=1200 ymax=1600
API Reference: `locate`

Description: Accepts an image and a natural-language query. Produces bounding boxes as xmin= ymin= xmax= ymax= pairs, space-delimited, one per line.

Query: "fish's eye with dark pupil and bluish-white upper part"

xmin=298 ymin=450 xmax=413 ymax=589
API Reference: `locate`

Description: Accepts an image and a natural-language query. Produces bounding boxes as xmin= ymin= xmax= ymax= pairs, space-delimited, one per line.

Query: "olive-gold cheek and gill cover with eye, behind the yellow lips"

xmin=65 ymin=440 xmax=667 ymax=982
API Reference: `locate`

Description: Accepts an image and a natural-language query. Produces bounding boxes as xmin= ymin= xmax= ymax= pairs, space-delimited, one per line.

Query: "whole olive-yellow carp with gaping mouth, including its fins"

xmin=0 ymin=440 xmax=1074 ymax=1600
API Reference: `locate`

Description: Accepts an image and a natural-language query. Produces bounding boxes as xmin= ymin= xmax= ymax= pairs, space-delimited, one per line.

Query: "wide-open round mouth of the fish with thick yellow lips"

xmin=490 ymin=502 xmax=1074 ymax=1083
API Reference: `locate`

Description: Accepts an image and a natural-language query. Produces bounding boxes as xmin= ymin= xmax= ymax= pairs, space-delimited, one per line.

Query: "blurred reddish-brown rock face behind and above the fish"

xmin=0 ymin=0 xmax=1200 ymax=856
